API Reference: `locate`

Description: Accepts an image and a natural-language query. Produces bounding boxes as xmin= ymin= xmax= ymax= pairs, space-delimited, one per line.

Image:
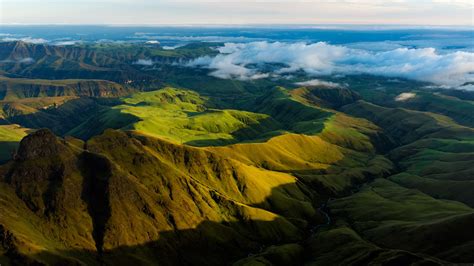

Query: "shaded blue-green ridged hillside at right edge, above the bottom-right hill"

xmin=344 ymin=102 xmax=474 ymax=206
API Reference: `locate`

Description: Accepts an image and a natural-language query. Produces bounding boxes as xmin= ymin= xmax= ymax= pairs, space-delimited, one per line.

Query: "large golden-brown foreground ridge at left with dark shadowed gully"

xmin=0 ymin=130 xmax=318 ymax=264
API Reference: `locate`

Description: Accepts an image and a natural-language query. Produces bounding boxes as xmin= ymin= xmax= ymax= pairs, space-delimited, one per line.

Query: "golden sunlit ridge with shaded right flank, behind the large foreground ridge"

xmin=208 ymin=114 xmax=392 ymax=196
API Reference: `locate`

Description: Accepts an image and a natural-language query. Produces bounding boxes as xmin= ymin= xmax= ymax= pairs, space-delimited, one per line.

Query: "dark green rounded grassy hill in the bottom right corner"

xmin=330 ymin=179 xmax=474 ymax=262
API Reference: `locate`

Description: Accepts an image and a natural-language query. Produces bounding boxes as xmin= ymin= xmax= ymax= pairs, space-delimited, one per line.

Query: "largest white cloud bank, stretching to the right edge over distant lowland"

xmin=187 ymin=42 xmax=474 ymax=86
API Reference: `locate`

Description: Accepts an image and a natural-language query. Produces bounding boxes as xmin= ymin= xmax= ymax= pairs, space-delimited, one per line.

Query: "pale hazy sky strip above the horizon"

xmin=0 ymin=0 xmax=474 ymax=26
